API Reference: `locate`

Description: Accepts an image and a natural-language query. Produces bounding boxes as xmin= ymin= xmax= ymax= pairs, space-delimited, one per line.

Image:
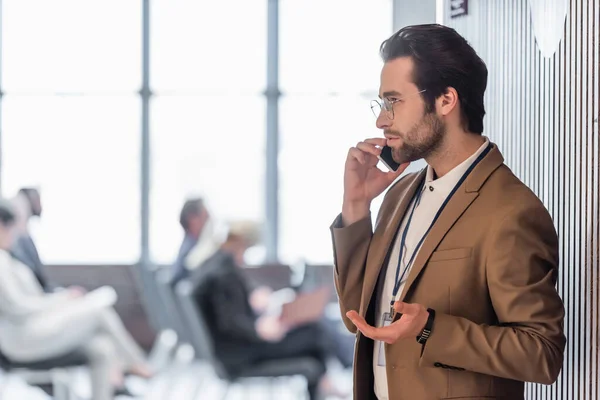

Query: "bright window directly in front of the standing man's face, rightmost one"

xmin=279 ymin=0 xmax=392 ymax=263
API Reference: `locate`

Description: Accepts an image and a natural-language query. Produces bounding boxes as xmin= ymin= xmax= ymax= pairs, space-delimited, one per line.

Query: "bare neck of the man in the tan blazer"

xmin=425 ymin=134 xmax=485 ymax=179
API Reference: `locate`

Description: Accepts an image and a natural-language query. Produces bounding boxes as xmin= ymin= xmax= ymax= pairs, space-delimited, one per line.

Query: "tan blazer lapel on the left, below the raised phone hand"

xmin=359 ymin=169 xmax=427 ymax=317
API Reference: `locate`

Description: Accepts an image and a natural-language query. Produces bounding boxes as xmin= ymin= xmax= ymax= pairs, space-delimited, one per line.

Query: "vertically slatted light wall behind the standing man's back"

xmin=444 ymin=0 xmax=600 ymax=400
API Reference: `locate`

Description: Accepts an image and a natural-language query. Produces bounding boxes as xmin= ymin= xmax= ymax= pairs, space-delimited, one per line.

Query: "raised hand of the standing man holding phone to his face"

xmin=342 ymin=138 xmax=409 ymax=226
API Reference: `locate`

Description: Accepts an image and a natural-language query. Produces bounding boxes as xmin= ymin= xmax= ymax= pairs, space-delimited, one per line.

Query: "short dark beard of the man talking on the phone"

xmin=386 ymin=112 xmax=446 ymax=164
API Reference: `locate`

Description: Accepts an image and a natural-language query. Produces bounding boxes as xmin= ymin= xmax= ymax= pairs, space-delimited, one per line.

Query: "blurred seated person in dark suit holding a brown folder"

xmin=191 ymin=222 xmax=344 ymax=399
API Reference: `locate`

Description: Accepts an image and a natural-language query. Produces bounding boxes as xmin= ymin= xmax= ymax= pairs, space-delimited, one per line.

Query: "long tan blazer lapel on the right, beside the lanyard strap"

xmin=398 ymin=145 xmax=504 ymax=304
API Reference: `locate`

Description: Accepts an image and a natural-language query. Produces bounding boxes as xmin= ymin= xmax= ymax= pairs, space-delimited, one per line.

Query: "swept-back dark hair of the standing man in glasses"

xmin=380 ymin=24 xmax=488 ymax=134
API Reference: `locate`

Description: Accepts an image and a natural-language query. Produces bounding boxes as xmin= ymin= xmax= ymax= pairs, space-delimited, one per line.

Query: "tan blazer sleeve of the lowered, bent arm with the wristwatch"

xmin=420 ymin=203 xmax=566 ymax=384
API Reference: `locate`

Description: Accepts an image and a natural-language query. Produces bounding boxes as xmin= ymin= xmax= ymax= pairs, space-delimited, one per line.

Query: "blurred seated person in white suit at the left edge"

xmin=0 ymin=200 xmax=151 ymax=400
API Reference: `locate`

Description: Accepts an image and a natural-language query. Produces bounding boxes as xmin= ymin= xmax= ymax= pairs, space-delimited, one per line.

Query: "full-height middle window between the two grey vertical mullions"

xmin=150 ymin=0 xmax=267 ymax=264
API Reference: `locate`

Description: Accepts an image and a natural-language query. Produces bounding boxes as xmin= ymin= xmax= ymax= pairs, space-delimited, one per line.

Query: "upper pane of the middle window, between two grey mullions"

xmin=150 ymin=0 xmax=267 ymax=94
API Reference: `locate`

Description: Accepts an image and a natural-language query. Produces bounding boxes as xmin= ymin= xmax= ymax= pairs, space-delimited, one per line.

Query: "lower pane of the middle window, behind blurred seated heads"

xmin=150 ymin=96 xmax=265 ymax=263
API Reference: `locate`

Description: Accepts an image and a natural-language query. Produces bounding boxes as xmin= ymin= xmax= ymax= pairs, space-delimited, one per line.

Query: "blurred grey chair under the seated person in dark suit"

xmin=176 ymin=276 xmax=321 ymax=399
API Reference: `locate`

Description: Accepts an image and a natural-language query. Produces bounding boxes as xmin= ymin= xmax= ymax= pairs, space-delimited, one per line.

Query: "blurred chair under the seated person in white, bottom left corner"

xmin=0 ymin=352 xmax=88 ymax=400
